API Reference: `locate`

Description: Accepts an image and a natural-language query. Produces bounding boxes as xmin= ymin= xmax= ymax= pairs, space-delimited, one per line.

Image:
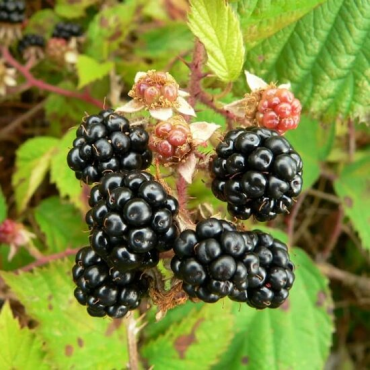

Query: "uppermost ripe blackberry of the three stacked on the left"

xmin=67 ymin=110 xmax=152 ymax=184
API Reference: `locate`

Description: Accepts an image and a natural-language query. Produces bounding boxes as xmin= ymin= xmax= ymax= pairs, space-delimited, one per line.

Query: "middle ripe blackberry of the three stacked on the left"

xmin=86 ymin=171 xmax=179 ymax=272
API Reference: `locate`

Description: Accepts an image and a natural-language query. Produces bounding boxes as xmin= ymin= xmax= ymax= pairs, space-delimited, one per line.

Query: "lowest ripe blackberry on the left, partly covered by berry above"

xmin=72 ymin=247 xmax=149 ymax=319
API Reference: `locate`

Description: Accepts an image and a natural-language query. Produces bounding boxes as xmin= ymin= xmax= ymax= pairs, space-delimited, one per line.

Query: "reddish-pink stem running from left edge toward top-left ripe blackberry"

xmin=1 ymin=46 xmax=103 ymax=109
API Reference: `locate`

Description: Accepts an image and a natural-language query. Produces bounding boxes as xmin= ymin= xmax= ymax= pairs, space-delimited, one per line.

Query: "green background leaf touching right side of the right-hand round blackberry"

xmin=286 ymin=116 xmax=334 ymax=189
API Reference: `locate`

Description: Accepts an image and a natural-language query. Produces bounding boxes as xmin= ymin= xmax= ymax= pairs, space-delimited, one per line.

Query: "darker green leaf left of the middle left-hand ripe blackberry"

xmin=35 ymin=197 xmax=88 ymax=253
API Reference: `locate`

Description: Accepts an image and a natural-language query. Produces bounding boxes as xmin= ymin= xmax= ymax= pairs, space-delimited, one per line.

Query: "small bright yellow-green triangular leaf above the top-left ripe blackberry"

xmin=77 ymin=55 xmax=114 ymax=89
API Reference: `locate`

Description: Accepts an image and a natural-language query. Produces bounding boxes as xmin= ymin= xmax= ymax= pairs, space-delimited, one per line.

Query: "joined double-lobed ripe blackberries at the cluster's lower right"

xmin=171 ymin=218 xmax=294 ymax=309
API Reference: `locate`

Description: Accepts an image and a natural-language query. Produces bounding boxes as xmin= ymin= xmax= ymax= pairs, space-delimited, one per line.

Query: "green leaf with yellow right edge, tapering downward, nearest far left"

xmin=12 ymin=137 xmax=58 ymax=212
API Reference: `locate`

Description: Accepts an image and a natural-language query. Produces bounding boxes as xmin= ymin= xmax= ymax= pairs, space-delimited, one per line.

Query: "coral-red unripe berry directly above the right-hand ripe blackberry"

xmin=256 ymin=88 xmax=302 ymax=133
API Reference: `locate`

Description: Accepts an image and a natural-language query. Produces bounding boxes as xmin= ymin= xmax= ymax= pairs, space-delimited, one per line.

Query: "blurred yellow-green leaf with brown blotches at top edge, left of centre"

xmin=86 ymin=0 xmax=140 ymax=61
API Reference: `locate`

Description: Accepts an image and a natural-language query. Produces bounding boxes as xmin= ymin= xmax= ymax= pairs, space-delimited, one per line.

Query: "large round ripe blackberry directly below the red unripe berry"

xmin=211 ymin=127 xmax=302 ymax=221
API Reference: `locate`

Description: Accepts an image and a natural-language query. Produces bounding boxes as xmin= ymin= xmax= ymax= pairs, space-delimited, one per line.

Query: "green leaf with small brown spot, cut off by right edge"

xmin=334 ymin=155 xmax=370 ymax=250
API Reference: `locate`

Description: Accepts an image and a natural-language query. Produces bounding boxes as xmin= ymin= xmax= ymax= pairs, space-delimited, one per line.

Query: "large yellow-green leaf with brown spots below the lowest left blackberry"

xmin=1 ymin=260 xmax=128 ymax=370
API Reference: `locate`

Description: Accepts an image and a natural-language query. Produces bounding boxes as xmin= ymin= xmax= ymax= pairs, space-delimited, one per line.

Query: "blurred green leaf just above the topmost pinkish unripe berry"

xmin=135 ymin=22 xmax=193 ymax=62
